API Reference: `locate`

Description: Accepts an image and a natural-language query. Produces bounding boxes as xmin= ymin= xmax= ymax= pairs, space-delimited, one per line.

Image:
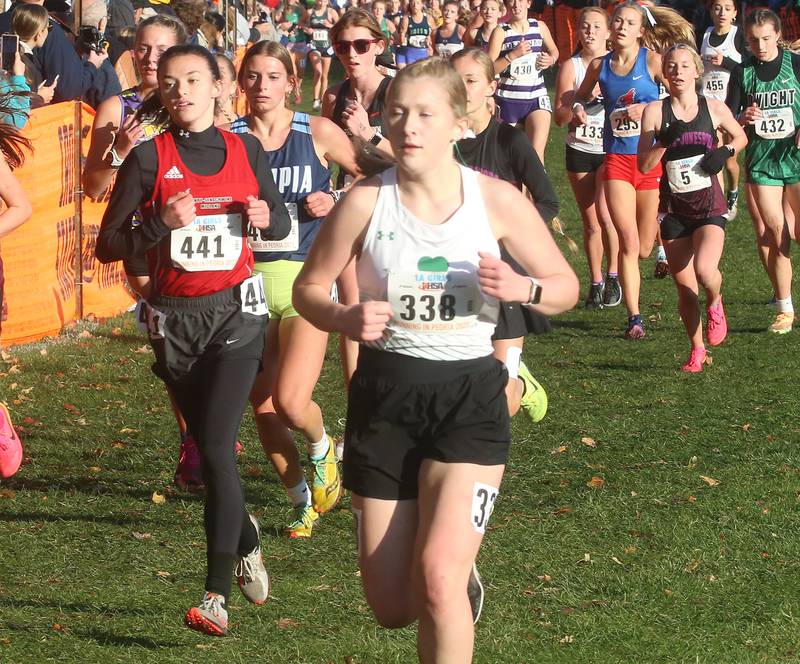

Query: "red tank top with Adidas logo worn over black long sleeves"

xmin=145 ymin=131 xmax=259 ymax=297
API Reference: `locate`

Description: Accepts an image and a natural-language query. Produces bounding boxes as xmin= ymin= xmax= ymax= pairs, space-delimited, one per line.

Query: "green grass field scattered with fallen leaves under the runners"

xmin=0 ymin=70 xmax=800 ymax=664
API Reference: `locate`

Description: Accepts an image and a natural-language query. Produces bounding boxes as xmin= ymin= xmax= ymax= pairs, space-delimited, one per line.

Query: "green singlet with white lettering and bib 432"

xmin=742 ymin=51 xmax=800 ymax=186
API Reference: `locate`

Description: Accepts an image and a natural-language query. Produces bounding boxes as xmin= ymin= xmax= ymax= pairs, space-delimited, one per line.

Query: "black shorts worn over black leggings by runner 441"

xmin=147 ymin=286 xmax=268 ymax=383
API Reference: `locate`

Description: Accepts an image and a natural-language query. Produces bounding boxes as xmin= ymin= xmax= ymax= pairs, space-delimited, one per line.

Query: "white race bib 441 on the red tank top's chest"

xmin=169 ymin=214 xmax=244 ymax=272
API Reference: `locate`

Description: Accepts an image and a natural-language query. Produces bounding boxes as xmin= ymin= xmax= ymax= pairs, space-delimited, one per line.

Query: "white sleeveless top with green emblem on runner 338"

xmin=356 ymin=166 xmax=500 ymax=360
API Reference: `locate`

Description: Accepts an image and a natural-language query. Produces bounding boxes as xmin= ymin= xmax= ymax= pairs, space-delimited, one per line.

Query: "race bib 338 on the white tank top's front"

xmin=388 ymin=268 xmax=483 ymax=334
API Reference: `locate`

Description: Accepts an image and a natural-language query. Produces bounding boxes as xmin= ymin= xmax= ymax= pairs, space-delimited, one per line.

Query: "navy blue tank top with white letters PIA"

xmin=230 ymin=112 xmax=332 ymax=262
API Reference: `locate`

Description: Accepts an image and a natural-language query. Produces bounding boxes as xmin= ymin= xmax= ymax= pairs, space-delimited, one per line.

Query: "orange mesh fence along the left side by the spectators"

xmin=0 ymin=102 xmax=133 ymax=346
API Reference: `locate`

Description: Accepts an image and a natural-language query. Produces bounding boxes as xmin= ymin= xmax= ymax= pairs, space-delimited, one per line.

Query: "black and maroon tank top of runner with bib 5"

xmin=659 ymin=97 xmax=727 ymax=220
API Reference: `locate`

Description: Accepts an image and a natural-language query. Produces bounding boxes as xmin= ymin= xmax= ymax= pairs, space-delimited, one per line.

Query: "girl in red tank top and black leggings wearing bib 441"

xmin=96 ymin=44 xmax=290 ymax=635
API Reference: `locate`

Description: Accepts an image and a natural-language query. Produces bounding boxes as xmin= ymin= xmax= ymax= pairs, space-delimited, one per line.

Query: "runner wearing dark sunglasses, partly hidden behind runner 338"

xmin=322 ymin=9 xmax=392 ymax=386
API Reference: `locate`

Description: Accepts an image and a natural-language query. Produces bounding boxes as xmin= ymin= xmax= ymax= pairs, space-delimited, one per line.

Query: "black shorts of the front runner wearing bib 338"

xmin=343 ymin=346 xmax=511 ymax=500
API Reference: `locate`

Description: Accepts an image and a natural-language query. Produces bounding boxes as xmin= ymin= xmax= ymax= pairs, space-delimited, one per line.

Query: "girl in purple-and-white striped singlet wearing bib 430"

xmin=488 ymin=0 xmax=558 ymax=163
